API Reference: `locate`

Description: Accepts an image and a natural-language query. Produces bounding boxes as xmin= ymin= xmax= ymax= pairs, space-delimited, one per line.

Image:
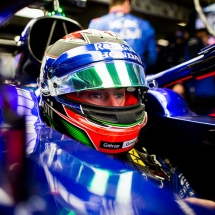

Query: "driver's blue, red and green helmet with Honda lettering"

xmin=38 ymin=29 xmax=148 ymax=154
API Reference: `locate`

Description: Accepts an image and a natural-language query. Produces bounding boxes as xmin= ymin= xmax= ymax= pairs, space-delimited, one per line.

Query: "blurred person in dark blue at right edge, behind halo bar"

xmin=184 ymin=25 xmax=215 ymax=115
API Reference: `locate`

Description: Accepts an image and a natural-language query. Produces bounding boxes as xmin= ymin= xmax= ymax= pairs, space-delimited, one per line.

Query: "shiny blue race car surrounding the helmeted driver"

xmin=0 ymin=0 xmax=214 ymax=214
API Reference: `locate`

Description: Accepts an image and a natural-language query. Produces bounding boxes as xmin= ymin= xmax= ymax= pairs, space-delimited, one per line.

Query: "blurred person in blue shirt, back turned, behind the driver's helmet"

xmin=88 ymin=0 xmax=157 ymax=73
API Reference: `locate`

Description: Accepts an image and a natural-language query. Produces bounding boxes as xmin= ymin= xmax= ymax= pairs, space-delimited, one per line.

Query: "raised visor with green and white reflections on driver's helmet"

xmin=48 ymin=61 xmax=147 ymax=96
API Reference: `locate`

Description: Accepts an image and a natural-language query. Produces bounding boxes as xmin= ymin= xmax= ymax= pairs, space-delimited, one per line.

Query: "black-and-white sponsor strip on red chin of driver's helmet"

xmin=100 ymin=138 xmax=136 ymax=150
